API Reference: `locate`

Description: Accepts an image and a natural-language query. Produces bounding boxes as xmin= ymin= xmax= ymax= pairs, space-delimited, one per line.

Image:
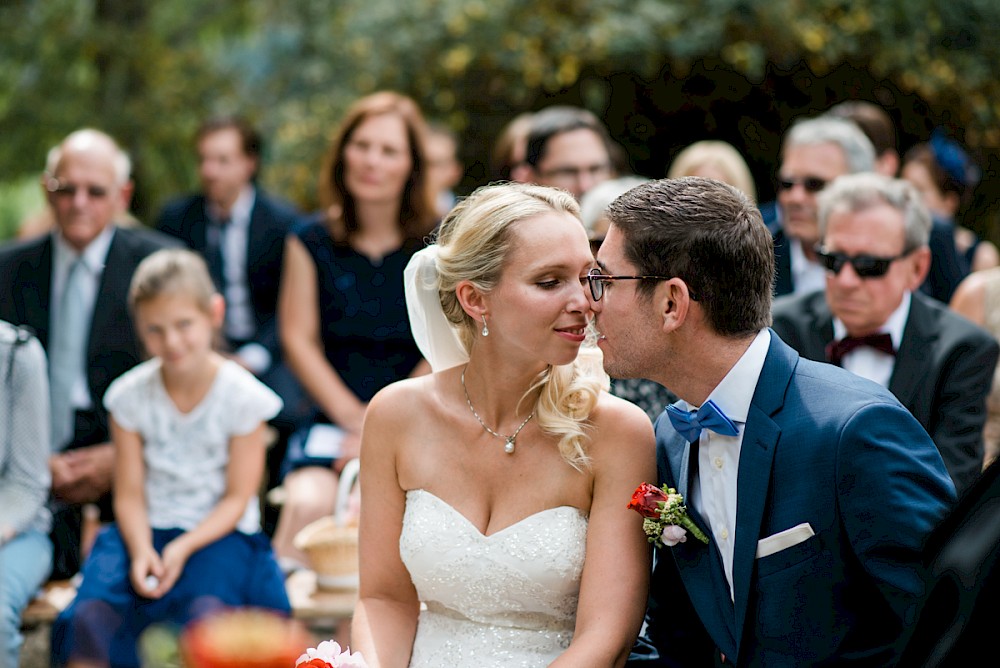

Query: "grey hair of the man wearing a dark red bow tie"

xmin=817 ymin=173 xmax=932 ymax=252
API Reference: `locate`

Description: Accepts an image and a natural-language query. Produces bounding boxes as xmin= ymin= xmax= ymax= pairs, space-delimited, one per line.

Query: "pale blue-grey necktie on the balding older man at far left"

xmin=49 ymin=258 xmax=90 ymax=452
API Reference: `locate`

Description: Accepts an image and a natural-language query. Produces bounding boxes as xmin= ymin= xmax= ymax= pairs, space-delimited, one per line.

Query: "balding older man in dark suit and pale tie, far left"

xmin=0 ymin=129 xmax=173 ymax=577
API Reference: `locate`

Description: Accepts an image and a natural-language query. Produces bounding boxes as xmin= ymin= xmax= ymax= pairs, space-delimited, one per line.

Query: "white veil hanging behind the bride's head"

xmin=403 ymin=244 xmax=469 ymax=371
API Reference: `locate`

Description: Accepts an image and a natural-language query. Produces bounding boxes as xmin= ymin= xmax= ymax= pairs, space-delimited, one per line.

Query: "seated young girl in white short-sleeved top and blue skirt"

xmin=52 ymin=249 xmax=290 ymax=668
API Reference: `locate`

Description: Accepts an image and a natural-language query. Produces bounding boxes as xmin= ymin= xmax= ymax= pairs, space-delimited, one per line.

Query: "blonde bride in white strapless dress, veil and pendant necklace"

xmin=353 ymin=184 xmax=656 ymax=668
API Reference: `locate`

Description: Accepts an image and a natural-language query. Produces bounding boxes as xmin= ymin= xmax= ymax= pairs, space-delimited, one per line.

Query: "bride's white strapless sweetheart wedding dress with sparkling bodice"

xmin=399 ymin=489 xmax=587 ymax=668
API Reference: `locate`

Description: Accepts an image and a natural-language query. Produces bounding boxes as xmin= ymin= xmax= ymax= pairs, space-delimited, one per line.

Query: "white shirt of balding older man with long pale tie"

xmin=49 ymin=225 xmax=115 ymax=410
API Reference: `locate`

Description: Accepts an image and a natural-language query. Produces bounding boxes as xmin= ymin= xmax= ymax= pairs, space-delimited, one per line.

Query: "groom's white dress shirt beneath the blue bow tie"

xmin=679 ymin=329 xmax=771 ymax=598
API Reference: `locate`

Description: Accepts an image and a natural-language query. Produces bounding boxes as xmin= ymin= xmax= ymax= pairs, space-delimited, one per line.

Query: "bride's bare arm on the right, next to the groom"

xmin=552 ymin=395 xmax=657 ymax=666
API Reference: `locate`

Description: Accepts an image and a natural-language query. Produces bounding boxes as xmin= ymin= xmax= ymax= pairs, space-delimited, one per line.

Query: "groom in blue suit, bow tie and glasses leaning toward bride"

xmin=590 ymin=178 xmax=955 ymax=666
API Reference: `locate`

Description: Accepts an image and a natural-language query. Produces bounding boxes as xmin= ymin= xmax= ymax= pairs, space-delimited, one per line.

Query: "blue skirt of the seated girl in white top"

xmin=52 ymin=525 xmax=291 ymax=668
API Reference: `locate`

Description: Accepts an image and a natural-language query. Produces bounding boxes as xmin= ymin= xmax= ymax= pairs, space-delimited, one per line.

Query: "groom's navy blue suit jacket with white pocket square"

xmin=630 ymin=332 xmax=955 ymax=666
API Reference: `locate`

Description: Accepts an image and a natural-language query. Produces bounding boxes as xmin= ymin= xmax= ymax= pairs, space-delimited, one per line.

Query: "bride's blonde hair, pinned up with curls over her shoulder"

xmin=437 ymin=183 xmax=608 ymax=470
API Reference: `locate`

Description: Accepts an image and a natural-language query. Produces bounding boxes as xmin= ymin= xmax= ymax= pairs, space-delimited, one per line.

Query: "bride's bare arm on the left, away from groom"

xmin=351 ymin=385 xmax=420 ymax=668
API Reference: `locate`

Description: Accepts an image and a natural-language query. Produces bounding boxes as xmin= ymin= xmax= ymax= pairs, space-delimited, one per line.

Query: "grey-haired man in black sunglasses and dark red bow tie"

xmin=774 ymin=174 xmax=998 ymax=491
